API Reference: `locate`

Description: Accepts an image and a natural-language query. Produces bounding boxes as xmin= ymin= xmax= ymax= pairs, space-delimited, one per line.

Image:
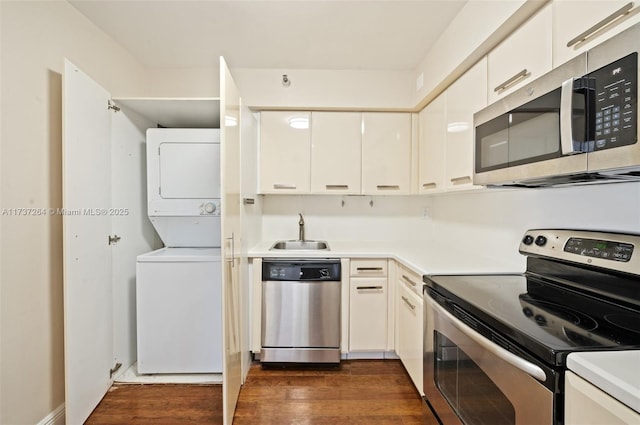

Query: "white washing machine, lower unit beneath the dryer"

xmin=136 ymin=248 xmax=222 ymax=374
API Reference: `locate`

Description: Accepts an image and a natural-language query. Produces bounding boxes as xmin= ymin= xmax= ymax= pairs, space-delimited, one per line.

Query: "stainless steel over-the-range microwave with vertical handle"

xmin=473 ymin=24 xmax=640 ymax=187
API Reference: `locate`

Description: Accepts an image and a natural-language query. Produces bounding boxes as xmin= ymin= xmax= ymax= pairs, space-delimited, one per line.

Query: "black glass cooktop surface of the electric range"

xmin=424 ymin=266 xmax=640 ymax=366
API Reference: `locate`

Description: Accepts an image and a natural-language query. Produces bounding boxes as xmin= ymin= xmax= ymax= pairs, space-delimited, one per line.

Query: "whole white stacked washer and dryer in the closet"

xmin=136 ymin=128 xmax=222 ymax=374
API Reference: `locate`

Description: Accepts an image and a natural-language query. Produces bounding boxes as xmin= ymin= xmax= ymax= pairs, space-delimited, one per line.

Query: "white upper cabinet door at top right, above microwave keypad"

xmin=553 ymin=0 xmax=640 ymax=67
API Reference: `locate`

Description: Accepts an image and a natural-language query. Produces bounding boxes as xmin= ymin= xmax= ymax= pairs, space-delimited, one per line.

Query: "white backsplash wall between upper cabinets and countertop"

xmin=262 ymin=183 xmax=640 ymax=272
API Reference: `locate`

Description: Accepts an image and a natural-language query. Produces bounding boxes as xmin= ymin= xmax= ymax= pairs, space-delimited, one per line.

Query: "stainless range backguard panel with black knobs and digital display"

xmin=519 ymin=229 xmax=640 ymax=275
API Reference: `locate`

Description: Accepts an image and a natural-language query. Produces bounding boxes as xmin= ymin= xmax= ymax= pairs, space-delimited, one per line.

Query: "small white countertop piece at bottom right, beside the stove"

xmin=567 ymin=350 xmax=640 ymax=413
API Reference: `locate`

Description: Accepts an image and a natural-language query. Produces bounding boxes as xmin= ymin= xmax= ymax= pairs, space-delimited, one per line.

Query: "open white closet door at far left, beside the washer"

xmin=58 ymin=61 xmax=114 ymax=424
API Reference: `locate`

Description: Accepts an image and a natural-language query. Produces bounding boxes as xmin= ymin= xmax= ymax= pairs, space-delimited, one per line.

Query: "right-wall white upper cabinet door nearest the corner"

xmin=418 ymin=94 xmax=444 ymax=193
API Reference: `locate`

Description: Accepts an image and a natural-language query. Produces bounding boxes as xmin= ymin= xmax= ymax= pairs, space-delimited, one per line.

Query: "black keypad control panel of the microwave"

xmin=589 ymin=53 xmax=638 ymax=150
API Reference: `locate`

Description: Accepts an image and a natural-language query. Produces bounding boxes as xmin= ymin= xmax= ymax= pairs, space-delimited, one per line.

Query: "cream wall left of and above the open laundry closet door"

xmin=0 ymin=0 xmax=211 ymax=425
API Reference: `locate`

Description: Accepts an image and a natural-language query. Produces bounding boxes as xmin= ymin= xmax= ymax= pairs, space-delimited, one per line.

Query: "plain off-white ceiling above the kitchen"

xmin=69 ymin=0 xmax=467 ymax=70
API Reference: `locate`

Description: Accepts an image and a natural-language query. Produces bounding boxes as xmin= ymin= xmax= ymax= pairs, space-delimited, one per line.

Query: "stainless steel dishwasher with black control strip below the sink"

xmin=260 ymin=258 xmax=341 ymax=363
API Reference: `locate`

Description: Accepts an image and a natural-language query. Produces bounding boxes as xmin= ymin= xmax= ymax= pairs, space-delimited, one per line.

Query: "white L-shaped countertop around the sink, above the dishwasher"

xmin=248 ymin=240 xmax=525 ymax=274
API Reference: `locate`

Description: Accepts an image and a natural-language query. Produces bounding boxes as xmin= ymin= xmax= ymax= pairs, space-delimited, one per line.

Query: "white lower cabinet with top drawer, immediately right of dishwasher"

xmin=349 ymin=259 xmax=388 ymax=352
